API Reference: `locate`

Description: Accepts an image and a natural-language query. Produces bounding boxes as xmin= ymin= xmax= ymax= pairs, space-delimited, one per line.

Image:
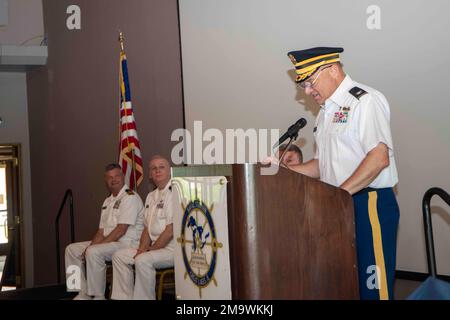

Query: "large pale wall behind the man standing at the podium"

xmin=180 ymin=0 xmax=450 ymax=275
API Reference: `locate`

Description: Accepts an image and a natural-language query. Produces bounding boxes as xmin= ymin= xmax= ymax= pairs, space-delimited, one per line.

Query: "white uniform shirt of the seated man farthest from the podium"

xmin=99 ymin=185 xmax=144 ymax=245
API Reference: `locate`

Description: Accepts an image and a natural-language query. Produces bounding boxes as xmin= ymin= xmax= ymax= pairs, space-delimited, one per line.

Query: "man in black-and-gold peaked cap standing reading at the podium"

xmin=288 ymin=47 xmax=399 ymax=299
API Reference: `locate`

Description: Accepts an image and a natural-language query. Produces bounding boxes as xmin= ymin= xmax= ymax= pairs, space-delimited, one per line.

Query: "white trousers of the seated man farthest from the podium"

xmin=65 ymin=241 xmax=128 ymax=296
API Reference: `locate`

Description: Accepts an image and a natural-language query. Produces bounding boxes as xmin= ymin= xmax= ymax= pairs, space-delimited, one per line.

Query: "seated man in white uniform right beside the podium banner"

xmin=111 ymin=156 xmax=174 ymax=300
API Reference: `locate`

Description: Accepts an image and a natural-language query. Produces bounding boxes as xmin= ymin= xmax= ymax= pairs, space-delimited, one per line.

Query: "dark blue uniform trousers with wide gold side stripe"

xmin=353 ymin=188 xmax=400 ymax=300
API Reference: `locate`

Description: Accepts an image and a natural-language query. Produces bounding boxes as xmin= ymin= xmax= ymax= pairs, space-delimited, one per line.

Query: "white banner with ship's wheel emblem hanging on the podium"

xmin=172 ymin=177 xmax=231 ymax=300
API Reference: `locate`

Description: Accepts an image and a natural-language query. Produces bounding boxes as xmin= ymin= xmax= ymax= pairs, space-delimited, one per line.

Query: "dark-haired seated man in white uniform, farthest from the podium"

xmin=65 ymin=163 xmax=144 ymax=300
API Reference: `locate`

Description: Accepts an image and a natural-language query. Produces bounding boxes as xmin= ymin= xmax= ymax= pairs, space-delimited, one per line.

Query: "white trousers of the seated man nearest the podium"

xmin=111 ymin=248 xmax=173 ymax=300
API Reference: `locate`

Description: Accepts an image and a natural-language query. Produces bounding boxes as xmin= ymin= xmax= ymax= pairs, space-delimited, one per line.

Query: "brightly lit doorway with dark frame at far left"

xmin=0 ymin=144 xmax=23 ymax=290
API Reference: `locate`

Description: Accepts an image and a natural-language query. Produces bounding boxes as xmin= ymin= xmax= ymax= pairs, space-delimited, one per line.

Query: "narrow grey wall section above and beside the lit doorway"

xmin=0 ymin=72 xmax=33 ymax=287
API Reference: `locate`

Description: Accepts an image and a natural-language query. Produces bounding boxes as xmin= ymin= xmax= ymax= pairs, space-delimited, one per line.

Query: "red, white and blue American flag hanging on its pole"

xmin=119 ymin=35 xmax=144 ymax=190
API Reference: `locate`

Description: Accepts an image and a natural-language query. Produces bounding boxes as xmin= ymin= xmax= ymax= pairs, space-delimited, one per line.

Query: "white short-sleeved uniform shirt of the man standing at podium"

xmin=314 ymin=75 xmax=398 ymax=188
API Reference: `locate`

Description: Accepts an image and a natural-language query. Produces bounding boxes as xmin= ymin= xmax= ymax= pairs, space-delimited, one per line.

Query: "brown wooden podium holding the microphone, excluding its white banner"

xmin=173 ymin=164 xmax=359 ymax=300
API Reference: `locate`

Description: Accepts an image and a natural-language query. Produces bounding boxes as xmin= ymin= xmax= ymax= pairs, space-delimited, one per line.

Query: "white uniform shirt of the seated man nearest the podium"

xmin=144 ymin=181 xmax=174 ymax=250
